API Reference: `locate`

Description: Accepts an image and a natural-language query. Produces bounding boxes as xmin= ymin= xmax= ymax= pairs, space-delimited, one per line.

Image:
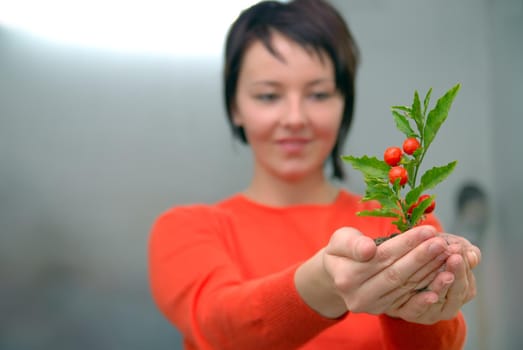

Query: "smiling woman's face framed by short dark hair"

xmin=233 ymin=33 xmax=344 ymax=181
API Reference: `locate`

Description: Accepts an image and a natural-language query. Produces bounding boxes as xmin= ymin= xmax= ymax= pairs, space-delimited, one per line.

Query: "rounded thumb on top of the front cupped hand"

xmin=326 ymin=227 xmax=376 ymax=262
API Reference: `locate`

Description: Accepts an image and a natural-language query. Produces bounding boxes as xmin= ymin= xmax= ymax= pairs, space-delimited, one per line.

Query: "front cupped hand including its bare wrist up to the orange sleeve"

xmin=294 ymin=226 xmax=450 ymax=318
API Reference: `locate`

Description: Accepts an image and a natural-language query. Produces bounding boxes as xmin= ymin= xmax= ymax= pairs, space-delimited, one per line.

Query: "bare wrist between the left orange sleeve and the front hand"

xmin=294 ymin=249 xmax=347 ymax=319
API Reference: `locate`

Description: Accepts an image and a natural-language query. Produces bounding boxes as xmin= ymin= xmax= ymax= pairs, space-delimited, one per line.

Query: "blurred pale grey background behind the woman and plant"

xmin=0 ymin=0 xmax=523 ymax=350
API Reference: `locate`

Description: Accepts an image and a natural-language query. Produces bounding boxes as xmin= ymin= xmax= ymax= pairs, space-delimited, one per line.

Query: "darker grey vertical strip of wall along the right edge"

xmin=488 ymin=0 xmax=523 ymax=349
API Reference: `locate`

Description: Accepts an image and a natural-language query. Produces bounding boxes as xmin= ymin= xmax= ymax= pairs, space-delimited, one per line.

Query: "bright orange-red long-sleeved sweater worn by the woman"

xmin=149 ymin=191 xmax=465 ymax=350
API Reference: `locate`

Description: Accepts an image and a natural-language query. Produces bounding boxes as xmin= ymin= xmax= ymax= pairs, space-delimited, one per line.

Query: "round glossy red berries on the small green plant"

xmin=383 ymin=137 xmax=436 ymax=214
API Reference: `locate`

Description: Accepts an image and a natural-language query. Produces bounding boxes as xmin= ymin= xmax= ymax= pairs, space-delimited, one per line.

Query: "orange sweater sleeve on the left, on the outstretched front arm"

xmin=149 ymin=206 xmax=339 ymax=349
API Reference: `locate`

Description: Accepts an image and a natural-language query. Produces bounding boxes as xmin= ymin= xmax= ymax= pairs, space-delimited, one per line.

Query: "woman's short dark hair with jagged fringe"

xmin=223 ymin=0 xmax=359 ymax=180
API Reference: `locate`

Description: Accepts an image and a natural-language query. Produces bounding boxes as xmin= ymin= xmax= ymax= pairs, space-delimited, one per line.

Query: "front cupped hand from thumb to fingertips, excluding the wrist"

xmin=323 ymin=226 xmax=450 ymax=314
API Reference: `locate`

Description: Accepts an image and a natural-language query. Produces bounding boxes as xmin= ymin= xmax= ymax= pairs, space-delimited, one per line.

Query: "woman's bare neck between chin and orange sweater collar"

xmin=244 ymin=167 xmax=339 ymax=207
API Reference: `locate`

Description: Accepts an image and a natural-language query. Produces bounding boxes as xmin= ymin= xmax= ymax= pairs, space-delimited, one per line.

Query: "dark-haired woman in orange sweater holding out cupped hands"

xmin=149 ymin=0 xmax=480 ymax=350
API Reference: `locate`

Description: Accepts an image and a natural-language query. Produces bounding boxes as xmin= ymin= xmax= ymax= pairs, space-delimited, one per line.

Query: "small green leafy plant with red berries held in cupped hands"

xmin=342 ymin=84 xmax=461 ymax=239
